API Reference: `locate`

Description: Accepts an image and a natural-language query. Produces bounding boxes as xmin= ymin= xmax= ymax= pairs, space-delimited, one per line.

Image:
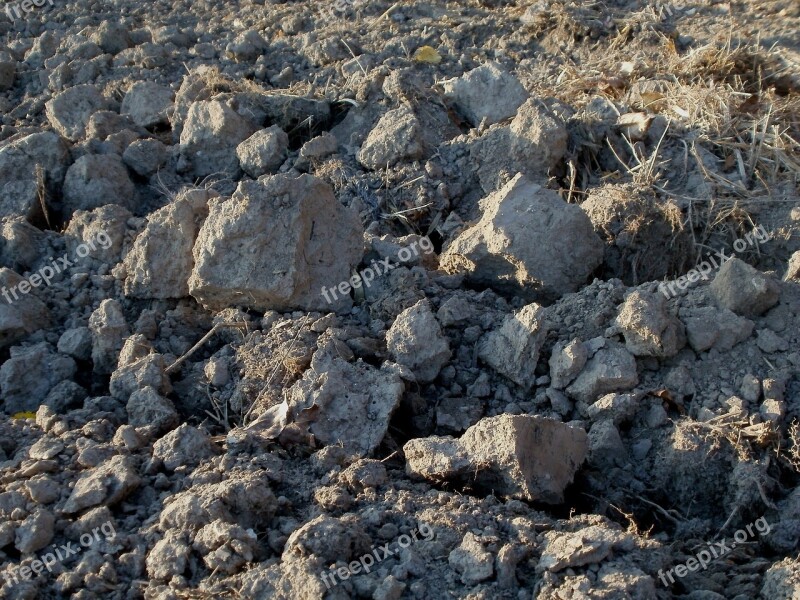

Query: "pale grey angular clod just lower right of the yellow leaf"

xmin=441 ymin=62 xmax=528 ymax=127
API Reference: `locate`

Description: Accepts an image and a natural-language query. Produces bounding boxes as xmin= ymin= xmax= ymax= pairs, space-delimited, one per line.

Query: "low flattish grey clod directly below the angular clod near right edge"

xmin=680 ymin=306 xmax=755 ymax=352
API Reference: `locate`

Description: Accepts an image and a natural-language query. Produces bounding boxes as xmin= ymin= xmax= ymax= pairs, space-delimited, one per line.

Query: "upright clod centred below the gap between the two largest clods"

xmin=386 ymin=300 xmax=451 ymax=383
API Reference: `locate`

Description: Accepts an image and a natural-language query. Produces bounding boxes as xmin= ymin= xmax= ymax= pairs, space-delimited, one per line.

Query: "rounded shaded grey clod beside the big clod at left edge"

xmin=63 ymin=154 xmax=136 ymax=216
